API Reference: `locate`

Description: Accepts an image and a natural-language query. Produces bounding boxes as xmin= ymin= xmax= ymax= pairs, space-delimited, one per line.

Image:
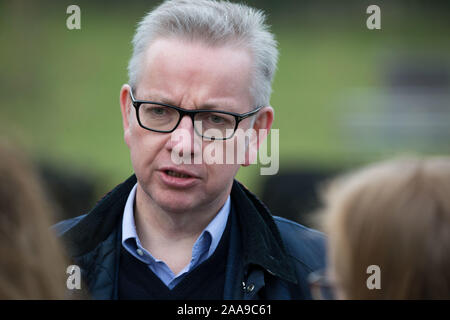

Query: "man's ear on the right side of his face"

xmin=242 ymin=106 xmax=274 ymax=167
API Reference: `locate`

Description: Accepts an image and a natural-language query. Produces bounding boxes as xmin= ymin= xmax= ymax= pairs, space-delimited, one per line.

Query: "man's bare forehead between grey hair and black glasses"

xmin=135 ymin=39 xmax=252 ymax=111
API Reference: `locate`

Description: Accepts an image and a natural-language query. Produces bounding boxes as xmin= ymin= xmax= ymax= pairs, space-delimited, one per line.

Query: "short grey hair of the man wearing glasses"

xmin=128 ymin=0 xmax=278 ymax=106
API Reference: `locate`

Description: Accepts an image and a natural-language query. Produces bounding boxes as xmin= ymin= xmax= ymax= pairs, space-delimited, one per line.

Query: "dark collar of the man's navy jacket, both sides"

xmin=62 ymin=175 xmax=297 ymax=283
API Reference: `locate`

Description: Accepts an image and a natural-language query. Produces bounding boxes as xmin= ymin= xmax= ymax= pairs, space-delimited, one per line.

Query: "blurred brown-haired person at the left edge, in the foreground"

xmin=0 ymin=141 xmax=68 ymax=299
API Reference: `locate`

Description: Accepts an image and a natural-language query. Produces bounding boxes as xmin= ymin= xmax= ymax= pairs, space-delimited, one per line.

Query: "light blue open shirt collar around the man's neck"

xmin=122 ymin=184 xmax=230 ymax=289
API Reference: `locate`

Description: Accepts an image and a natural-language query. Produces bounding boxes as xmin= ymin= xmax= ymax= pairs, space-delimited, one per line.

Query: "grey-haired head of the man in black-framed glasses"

xmin=120 ymin=0 xmax=277 ymax=212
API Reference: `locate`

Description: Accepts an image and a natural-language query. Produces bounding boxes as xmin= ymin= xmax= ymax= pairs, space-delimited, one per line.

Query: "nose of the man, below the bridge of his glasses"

xmin=167 ymin=115 xmax=201 ymax=163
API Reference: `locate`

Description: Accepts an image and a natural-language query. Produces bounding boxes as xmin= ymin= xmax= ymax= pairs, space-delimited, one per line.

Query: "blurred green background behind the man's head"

xmin=0 ymin=0 xmax=450 ymax=224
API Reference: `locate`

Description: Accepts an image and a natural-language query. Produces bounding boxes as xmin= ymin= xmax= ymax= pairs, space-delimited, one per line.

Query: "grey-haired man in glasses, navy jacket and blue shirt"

xmin=56 ymin=0 xmax=324 ymax=299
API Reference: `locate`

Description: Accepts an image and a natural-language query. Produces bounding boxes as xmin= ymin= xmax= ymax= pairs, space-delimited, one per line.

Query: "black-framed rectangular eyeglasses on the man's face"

xmin=130 ymin=88 xmax=262 ymax=140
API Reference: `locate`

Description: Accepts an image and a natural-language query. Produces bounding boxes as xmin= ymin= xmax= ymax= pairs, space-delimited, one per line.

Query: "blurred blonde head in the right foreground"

xmin=325 ymin=158 xmax=450 ymax=299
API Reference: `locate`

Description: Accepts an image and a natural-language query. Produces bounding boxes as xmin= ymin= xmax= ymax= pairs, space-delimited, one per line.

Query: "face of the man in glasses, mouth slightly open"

xmin=121 ymin=39 xmax=272 ymax=213
